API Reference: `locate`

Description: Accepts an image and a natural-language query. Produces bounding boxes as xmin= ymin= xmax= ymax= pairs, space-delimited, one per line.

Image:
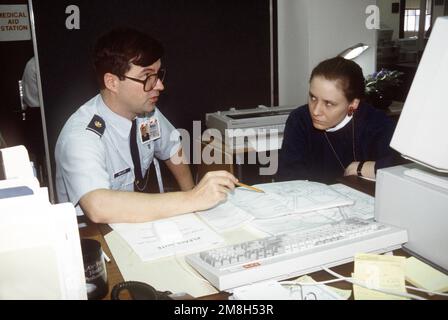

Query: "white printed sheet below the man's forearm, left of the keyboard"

xmin=110 ymin=214 xmax=224 ymax=261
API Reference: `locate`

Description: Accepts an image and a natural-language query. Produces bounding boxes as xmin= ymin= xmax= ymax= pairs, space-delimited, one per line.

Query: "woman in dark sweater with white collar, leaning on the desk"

xmin=278 ymin=57 xmax=395 ymax=183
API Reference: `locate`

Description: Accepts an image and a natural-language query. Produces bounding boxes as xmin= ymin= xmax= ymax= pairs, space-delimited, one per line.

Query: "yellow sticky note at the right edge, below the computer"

xmin=406 ymin=257 xmax=448 ymax=292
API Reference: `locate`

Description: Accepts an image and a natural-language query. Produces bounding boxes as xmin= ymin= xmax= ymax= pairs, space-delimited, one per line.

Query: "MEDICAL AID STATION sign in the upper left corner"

xmin=0 ymin=4 xmax=31 ymax=41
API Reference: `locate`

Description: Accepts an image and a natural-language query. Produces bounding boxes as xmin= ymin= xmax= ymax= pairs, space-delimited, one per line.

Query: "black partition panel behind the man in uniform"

xmin=33 ymin=0 xmax=271 ymax=190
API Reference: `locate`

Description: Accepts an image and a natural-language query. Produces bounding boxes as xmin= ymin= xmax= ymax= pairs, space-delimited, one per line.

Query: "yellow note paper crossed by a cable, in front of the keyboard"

xmin=353 ymin=254 xmax=406 ymax=300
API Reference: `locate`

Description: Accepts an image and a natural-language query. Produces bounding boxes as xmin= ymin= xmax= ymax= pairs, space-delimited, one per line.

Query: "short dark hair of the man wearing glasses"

xmin=93 ymin=28 xmax=164 ymax=89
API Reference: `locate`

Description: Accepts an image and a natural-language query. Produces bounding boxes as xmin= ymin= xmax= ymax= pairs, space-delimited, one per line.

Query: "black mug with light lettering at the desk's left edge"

xmin=81 ymin=239 xmax=109 ymax=300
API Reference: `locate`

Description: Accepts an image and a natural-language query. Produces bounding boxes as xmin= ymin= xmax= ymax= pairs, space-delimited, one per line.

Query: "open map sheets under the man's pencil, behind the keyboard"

xmin=197 ymin=181 xmax=355 ymax=234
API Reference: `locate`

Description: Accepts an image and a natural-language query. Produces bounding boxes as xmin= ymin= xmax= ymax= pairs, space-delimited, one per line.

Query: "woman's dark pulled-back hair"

xmin=310 ymin=57 xmax=366 ymax=101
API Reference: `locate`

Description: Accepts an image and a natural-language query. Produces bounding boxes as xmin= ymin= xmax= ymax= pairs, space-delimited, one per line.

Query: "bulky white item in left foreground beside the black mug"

xmin=0 ymin=146 xmax=87 ymax=300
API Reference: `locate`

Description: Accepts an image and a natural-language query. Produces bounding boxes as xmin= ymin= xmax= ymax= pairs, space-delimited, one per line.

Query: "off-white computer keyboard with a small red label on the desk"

xmin=185 ymin=218 xmax=407 ymax=290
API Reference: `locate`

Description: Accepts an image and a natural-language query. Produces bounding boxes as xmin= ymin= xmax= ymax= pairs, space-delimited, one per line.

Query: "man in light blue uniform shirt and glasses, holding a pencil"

xmin=55 ymin=29 xmax=237 ymax=223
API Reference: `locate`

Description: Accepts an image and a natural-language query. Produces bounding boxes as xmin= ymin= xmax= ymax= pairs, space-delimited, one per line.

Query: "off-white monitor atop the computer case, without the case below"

xmin=390 ymin=17 xmax=448 ymax=173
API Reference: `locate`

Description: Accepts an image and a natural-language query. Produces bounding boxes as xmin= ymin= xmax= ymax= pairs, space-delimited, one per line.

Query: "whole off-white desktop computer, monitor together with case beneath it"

xmin=375 ymin=17 xmax=448 ymax=273
